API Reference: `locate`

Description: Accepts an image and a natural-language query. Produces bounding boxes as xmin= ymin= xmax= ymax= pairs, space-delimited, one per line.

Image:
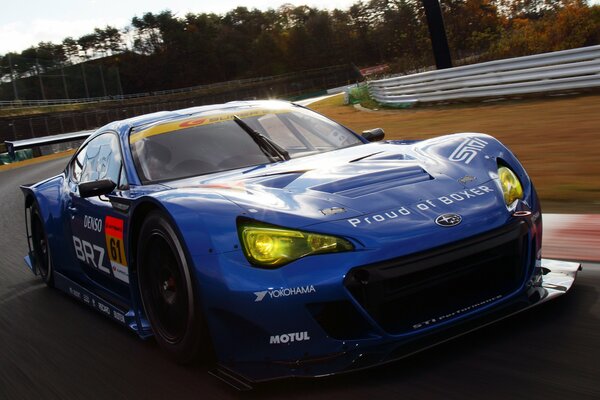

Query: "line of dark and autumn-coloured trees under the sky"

xmin=0 ymin=0 xmax=600 ymax=93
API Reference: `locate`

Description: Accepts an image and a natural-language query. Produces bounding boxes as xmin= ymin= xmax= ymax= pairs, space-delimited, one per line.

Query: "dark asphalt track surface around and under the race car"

xmin=0 ymin=155 xmax=600 ymax=400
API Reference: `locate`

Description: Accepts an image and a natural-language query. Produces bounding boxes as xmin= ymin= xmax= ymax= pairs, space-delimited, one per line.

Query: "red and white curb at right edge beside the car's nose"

xmin=542 ymin=214 xmax=600 ymax=262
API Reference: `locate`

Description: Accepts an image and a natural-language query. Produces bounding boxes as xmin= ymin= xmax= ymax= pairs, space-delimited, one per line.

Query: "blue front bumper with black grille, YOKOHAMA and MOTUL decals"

xmin=194 ymin=190 xmax=580 ymax=382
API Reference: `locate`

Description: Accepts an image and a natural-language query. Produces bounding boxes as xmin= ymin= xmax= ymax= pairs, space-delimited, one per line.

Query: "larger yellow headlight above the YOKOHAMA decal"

xmin=238 ymin=221 xmax=354 ymax=267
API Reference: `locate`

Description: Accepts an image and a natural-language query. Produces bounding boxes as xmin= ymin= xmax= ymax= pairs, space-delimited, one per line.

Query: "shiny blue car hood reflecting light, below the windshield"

xmin=166 ymin=134 xmax=507 ymax=226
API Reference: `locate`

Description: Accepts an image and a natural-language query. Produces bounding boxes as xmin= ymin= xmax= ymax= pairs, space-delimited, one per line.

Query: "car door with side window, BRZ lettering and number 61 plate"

xmin=67 ymin=132 xmax=129 ymax=292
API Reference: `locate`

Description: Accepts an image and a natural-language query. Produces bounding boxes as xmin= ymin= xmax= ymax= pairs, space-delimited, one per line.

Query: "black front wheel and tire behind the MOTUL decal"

xmin=137 ymin=211 xmax=210 ymax=364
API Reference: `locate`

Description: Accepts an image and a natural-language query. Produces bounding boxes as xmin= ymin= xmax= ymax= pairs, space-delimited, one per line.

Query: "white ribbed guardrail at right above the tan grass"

xmin=368 ymin=46 xmax=600 ymax=105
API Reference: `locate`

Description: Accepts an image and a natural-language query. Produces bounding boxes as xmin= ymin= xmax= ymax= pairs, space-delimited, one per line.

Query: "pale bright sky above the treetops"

xmin=0 ymin=0 xmax=358 ymax=54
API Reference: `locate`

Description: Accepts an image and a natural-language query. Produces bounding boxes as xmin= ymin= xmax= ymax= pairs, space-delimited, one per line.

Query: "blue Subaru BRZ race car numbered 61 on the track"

xmin=22 ymin=101 xmax=580 ymax=387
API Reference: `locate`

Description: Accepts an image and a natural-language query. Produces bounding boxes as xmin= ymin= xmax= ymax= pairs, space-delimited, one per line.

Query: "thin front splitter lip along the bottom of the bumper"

xmin=215 ymin=259 xmax=582 ymax=388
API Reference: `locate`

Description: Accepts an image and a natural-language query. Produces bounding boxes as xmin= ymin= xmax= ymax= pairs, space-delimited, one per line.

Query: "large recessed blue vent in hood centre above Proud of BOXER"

xmin=311 ymin=165 xmax=433 ymax=198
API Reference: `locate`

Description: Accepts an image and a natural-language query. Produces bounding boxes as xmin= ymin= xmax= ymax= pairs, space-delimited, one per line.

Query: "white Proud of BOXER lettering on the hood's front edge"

xmin=346 ymin=185 xmax=494 ymax=228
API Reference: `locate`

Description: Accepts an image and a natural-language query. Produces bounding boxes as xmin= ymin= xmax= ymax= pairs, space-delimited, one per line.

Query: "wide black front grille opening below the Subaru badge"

xmin=344 ymin=221 xmax=529 ymax=334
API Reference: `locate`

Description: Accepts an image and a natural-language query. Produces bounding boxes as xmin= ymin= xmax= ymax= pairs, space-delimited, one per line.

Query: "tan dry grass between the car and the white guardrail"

xmin=310 ymin=91 xmax=600 ymax=213
